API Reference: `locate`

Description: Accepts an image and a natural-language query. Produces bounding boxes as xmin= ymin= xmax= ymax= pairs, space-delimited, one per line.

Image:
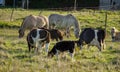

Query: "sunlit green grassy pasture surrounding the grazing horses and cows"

xmin=0 ymin=8 xmax=120 ymax=72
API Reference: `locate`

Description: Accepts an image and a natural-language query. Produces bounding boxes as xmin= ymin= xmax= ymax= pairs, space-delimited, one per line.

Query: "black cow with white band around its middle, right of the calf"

xmin=78 ymin=28 xmax=106 ymax=51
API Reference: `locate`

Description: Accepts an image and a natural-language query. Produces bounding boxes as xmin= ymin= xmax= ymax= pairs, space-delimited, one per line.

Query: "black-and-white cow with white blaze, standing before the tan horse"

xmin=27 ymin=29 xmax=50 ymax=53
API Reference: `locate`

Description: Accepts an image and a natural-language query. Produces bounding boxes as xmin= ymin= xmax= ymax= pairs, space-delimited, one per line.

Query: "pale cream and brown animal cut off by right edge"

xmin=111 ymin=27 xmax=120 ymax=41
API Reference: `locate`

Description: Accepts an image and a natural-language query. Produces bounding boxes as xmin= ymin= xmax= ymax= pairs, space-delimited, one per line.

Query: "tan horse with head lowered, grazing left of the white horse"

xmin=18 ymin=15 xmax=49 ymax=38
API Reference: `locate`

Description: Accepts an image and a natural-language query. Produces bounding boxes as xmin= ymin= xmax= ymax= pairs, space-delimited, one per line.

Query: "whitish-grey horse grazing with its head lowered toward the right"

xmin=48 ymin=14 xmax=80 ymax=38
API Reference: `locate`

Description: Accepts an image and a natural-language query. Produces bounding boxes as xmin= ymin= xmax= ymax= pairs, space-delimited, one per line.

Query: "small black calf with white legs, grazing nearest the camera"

xmin=48 ymin=41 xmax=78 ymax=59
